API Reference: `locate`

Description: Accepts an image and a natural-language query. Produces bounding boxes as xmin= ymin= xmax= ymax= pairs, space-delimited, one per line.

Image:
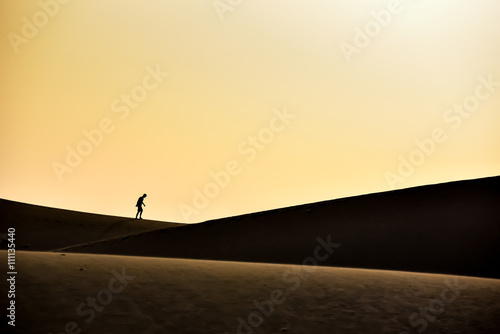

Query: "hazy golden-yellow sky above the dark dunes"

xmin=0 ymin=0 xmax=500 ymax=223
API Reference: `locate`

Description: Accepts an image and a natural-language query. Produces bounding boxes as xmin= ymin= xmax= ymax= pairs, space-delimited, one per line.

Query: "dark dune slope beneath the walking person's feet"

xmin=0 ymin=199 xmax=183 ymax=250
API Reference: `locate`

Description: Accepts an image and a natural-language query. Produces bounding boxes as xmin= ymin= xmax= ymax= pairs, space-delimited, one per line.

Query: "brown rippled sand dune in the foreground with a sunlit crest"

xmin=0 ymin=251 xmax=500 ymax=334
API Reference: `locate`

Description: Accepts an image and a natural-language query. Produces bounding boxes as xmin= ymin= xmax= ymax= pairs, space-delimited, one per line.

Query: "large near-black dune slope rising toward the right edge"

xmin=61 ymin=177 xmax=500 ymax=278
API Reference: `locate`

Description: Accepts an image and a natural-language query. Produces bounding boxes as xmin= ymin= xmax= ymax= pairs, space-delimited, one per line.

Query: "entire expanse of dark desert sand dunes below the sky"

xmin=0 ymin=177 xmax=500 ymax=334
